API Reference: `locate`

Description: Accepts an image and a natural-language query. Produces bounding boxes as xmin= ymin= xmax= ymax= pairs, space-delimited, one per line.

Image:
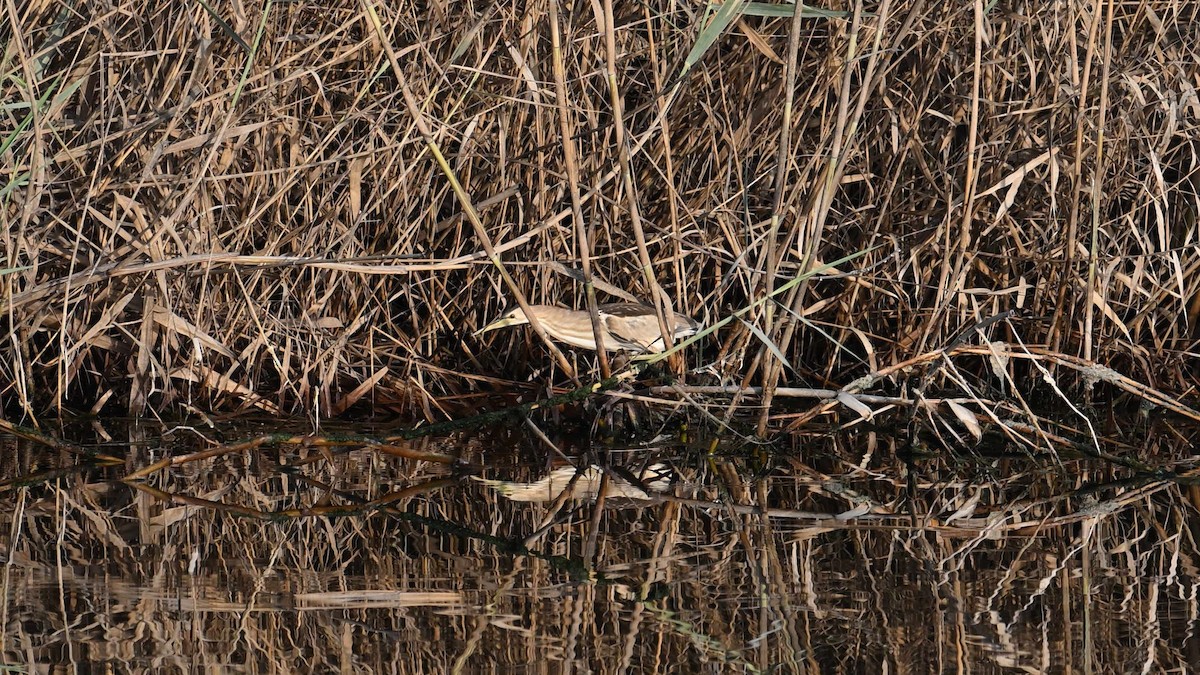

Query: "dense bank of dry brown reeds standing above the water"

xmin=0 ymin=0 xmax=1200 ymax=426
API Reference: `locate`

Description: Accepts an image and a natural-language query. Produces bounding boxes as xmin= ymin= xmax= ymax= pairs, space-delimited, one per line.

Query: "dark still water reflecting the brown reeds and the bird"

xmin=0 ymin=413 xmax=1200 ymax=673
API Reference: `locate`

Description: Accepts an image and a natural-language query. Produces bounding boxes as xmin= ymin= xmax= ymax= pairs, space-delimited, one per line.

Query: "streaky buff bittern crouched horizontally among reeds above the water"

xmin=475 ymin=303 xmax=700 ymax=353
